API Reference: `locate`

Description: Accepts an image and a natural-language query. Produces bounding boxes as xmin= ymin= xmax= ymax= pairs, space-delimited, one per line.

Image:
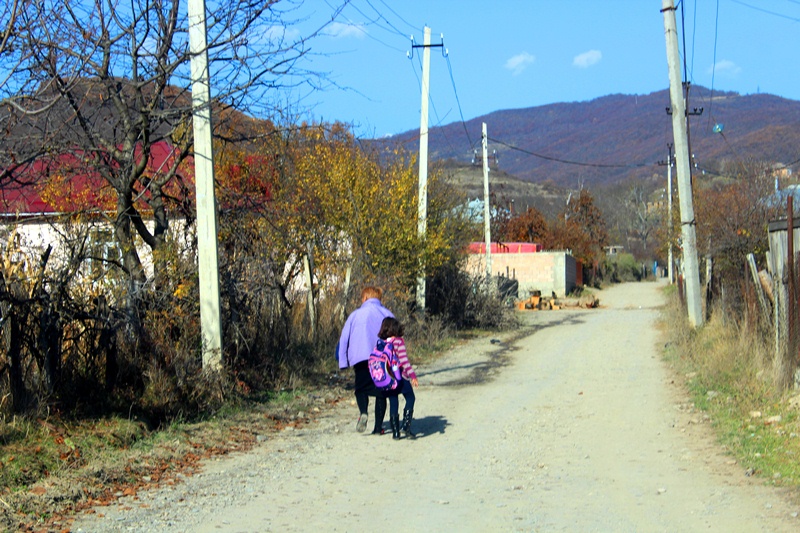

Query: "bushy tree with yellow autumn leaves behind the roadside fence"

xmin=216 ymin=124 xmax=469 ymax=312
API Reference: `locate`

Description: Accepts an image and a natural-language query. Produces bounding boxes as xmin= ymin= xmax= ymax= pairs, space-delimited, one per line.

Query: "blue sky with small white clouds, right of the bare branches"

xmin=287 ymin=0 xmax=800 ymax=137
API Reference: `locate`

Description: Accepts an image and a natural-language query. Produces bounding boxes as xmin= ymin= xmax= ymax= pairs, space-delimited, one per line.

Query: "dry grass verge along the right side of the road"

xmin=664 ymin=288 xmax=800 ymax=488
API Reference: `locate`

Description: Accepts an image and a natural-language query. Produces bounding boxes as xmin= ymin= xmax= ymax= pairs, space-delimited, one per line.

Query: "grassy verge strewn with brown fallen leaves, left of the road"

xmin=0 ymin=384 xmax=346 ymax=531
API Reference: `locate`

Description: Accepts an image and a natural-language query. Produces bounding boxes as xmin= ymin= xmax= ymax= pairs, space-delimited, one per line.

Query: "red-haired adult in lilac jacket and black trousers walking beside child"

xmin=337 ymin=287 xmax=394 ymax=435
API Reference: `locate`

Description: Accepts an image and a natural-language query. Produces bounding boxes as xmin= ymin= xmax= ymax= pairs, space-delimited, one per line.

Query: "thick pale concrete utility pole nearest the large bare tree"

xmin=188 ymin=0 xmax=222 ymax=371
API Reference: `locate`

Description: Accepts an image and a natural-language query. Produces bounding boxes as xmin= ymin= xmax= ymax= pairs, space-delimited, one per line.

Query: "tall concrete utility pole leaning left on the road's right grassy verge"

xmin=661 ymin=0 xmax=705 ymax=327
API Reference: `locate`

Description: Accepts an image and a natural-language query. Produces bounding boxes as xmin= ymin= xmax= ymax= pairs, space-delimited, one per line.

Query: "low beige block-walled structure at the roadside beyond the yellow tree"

xmin=466 ymin=252 xmax=576 ymax=298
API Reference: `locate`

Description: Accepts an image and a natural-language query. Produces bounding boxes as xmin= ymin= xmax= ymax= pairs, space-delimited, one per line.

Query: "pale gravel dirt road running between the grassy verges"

xmin=73 ymin=283 xmax=800 ymax=532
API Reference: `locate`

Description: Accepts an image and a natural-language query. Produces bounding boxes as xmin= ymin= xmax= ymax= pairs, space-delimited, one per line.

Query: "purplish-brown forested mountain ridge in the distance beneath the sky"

xmin=390 ymin=86 xmax=800 ymax=189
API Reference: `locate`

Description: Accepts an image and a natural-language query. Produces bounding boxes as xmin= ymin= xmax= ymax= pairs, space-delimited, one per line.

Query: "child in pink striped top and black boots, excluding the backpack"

xmin=378 ymin=317 xmax=419 ymax=439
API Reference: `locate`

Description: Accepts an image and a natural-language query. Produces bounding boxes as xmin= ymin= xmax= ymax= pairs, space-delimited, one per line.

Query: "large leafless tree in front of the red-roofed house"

xmin=0 ymin=0 xmax=338 ymax=285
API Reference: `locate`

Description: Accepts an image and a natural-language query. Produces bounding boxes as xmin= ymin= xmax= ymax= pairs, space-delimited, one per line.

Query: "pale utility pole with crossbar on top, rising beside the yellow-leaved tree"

xmin=408 ymin=26 xmax=445 ymax=314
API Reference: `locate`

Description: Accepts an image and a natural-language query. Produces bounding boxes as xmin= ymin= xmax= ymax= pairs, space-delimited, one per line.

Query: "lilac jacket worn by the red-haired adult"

xmin=337 ymin=298 xmax=394 ymax=368
